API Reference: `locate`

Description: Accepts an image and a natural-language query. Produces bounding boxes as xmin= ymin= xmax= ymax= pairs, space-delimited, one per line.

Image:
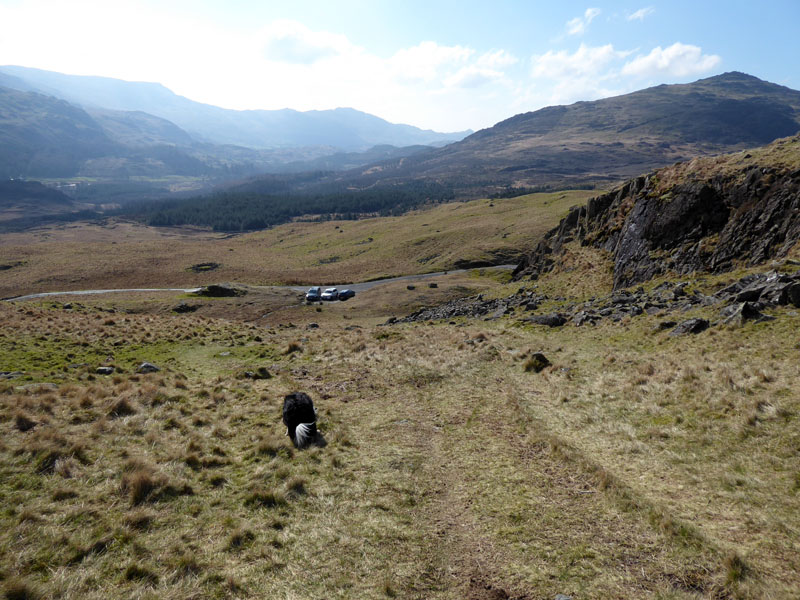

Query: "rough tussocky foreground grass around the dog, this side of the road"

xmin=0 ymin=240 xmax=800 ymax=600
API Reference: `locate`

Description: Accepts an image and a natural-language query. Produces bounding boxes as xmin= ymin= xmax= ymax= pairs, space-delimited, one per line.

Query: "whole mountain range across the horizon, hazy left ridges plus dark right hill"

xmin=0 ymin=67 xmax=800 ymax=226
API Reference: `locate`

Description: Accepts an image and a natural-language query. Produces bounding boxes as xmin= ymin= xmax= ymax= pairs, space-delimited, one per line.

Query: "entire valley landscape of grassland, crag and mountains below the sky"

xmin=0 ymin=59 xmax=800 ymax=600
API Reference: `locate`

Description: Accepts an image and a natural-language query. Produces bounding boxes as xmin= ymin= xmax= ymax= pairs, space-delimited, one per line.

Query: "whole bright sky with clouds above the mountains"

xmin=0 ymin=0 xmax=800 ymax=132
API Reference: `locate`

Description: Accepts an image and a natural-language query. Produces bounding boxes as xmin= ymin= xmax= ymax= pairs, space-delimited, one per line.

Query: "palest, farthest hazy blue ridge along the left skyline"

xmin=0 ymin=66 xmax=471 ymax=151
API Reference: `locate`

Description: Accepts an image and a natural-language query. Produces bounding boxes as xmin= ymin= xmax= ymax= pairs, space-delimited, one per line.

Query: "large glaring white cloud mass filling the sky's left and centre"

xmin=0 ymin=0 xmax=732 ymax=131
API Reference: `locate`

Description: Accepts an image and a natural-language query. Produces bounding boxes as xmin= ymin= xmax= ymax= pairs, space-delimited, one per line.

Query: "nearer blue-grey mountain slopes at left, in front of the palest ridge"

xmin=0 ymin=77 xmax=450 ymax=184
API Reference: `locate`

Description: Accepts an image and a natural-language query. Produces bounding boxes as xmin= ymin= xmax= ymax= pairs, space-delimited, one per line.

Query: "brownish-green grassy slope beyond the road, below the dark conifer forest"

xmin=0 ymin=191 xmax=596 ymax=298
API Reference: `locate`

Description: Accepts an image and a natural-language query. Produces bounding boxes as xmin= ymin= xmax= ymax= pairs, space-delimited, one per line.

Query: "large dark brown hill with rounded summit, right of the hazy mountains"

xmin=332 ymin=73 xmax=800 ymax=195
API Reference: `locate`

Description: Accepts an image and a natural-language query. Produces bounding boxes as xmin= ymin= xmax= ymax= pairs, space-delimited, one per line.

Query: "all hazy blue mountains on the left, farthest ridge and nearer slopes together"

xmin=0 ymin=67 xmax=470 ymax=180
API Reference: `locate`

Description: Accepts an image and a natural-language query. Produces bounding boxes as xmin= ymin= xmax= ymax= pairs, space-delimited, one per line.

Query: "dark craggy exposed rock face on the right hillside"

xmin=514 ymin=137 xmax=800 ymax=289
